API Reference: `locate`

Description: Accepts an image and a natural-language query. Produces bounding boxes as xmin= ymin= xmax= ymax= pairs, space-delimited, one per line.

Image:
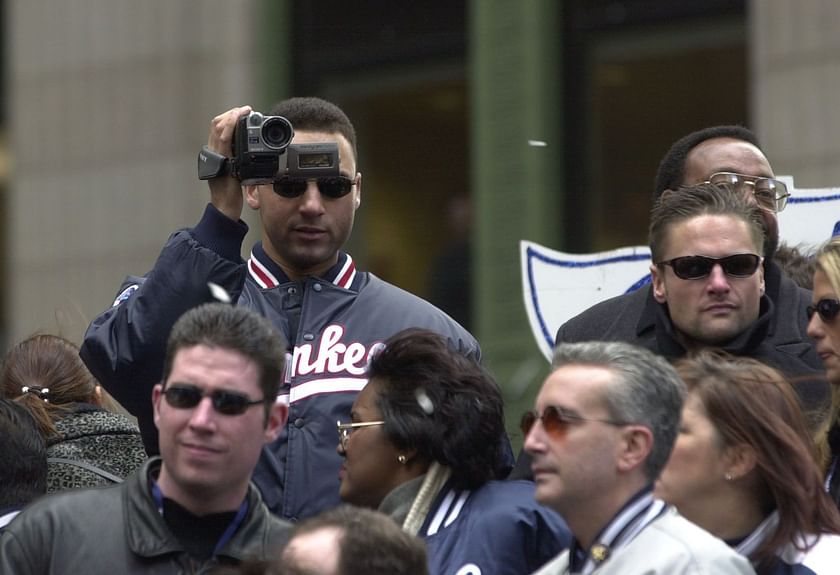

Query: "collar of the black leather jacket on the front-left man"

xmin=121 ymin=457 xmax=270 ymax=562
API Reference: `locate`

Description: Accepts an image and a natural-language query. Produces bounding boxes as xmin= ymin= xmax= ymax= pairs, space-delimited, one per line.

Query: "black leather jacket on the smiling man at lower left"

xmin=0 ymin=458 xmax=290 ymax=575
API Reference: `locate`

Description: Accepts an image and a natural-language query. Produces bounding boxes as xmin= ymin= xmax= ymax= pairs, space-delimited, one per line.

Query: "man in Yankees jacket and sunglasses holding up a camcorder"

xmin=81 ymin=98 xmax=480 ymax=520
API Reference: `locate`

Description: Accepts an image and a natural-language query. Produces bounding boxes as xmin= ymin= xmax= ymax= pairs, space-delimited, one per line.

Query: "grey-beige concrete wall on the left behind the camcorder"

xmin=5 ymin=0 xmax=257 ymax=342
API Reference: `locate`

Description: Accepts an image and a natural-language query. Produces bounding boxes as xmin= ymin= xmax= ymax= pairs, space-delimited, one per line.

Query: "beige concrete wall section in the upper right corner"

xmin=748 ymin=0 xmax=840 ymax=188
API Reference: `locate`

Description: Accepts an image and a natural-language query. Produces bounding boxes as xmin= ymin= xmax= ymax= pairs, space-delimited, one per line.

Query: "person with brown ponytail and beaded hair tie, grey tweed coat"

xmin=0 ymin=335 xmax=151 ymax=493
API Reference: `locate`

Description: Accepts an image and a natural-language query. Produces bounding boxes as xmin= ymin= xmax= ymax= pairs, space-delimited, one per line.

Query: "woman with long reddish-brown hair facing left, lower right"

xmin=656 ymin=351 xmax=840 ymax=575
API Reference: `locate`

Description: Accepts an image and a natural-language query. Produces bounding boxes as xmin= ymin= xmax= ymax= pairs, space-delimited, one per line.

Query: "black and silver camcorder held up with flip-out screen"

xmin=198 ymin=112 xmax=340 ymax=185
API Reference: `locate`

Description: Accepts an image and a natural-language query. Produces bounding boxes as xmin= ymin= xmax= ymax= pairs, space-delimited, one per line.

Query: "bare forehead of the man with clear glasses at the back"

xmin=682 ymin=138 xmax=773 ymax=185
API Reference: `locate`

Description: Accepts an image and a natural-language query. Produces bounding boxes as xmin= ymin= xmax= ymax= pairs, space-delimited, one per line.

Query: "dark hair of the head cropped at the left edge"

xmin=0 ymin=398 xmax=47 ymax=509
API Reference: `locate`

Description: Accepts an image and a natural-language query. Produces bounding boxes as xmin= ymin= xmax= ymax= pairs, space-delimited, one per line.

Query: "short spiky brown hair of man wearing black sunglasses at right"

xmin=648 ymin=184 xmax=765 ymax=262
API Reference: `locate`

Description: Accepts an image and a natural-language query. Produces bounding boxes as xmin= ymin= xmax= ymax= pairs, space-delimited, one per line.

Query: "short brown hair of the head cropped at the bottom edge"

xmin=272 ymin=505 xmax=429 ymax=575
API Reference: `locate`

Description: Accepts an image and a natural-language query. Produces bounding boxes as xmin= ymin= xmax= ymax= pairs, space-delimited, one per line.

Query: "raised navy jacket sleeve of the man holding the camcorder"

xmin=80 ymin=205 xmax=248 ymax=453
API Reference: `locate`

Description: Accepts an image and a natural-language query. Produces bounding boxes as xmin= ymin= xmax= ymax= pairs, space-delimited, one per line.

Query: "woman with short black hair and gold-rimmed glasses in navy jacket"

xmin=338 ymin=330 xmax=571 ymax=575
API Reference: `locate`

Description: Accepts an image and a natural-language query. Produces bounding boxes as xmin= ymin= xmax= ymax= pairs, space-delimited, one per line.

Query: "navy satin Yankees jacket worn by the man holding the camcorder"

xmin=81 ymin=204 xmax=480 ymax=520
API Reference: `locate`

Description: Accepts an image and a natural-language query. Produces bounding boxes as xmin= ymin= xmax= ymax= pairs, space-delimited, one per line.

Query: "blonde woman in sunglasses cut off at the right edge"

xmin=808 ymin=237 xmax=840 ymax=507
